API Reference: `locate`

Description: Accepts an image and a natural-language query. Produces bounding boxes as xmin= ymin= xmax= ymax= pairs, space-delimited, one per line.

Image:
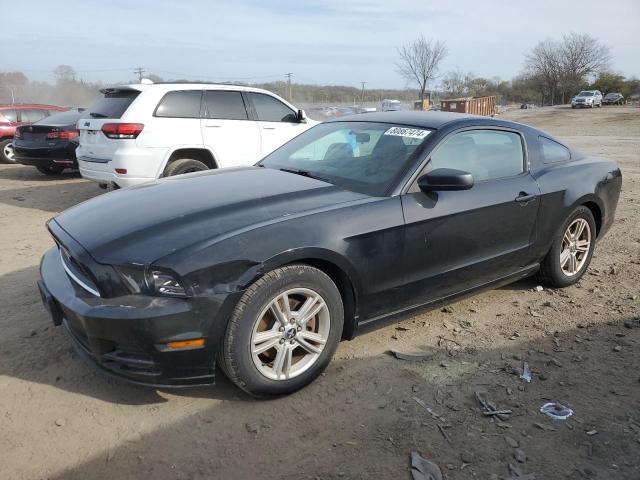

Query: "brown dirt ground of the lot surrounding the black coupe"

xmin=0 ymin=107 xmax=640 ymax=480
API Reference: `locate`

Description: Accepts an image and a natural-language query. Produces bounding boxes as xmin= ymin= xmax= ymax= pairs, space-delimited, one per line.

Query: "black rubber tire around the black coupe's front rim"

xmin=218 ymin=264 xmax=344 ymax=397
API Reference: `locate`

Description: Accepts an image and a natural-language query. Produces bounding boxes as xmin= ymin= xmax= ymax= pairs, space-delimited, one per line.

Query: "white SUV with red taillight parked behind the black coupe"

xmin=76 ymin=80 xmax=317 ymax=187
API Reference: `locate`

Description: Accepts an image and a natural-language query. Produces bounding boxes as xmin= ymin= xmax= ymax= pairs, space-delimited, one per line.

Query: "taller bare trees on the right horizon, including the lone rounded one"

xmin=396 ymin=32 xmax=640 ymax=105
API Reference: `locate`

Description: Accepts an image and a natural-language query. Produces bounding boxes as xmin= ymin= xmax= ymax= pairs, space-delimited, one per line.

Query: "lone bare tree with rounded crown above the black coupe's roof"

xmin=396 ymin=35 xmax=449 ymax=100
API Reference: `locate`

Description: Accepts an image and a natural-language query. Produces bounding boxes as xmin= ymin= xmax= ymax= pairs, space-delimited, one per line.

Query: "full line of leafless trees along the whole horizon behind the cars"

xmin=0 ymin=33 xmax=640 ymax=107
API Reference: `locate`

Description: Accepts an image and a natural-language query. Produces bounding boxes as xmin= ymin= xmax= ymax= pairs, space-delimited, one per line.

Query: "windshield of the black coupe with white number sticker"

xmin=259 ymin=122 xmax=431 ymax=196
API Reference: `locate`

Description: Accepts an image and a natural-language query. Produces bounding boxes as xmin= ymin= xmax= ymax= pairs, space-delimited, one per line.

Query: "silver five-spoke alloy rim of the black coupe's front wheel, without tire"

xmin=251 ymin=288 xmax=331 ymax=380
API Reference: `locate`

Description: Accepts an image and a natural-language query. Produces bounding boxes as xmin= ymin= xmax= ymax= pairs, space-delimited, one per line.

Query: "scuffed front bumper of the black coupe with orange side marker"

xmin=38 ymin=248 xmax=236 ymax=387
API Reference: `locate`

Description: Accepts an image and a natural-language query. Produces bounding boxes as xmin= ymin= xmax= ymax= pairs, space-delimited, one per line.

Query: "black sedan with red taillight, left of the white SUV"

xmin=13 ymin=109 xmax=82 ymax=175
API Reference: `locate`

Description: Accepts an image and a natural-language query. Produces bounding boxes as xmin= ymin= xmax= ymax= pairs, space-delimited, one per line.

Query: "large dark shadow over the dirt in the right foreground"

xmin=36 ymin=323 xmax=640 ymax=480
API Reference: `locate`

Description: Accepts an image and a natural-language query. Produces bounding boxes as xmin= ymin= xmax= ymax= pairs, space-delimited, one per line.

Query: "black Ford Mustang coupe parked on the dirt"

xmin=39 ymin=112 xmax=622 ymax=396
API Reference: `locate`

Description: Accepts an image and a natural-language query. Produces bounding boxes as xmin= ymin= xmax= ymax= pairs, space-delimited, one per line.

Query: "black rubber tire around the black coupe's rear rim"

xmin=538 ymin=205 xmax=596 ymax=288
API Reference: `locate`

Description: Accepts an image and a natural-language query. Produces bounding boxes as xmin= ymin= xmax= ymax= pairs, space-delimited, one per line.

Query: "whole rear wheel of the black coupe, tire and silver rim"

xmin=538 ymin=206 xmax=596 ymax=287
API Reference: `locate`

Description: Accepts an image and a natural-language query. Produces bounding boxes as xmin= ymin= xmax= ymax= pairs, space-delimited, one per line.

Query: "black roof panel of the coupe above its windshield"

xmin=329 ymin=110 xmax=520 ymax=129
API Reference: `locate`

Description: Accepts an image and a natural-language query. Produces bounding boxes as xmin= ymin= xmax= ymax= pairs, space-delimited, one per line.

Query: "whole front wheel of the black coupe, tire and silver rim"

xmin=219 ymin=265 xmax=344 ymax=397
